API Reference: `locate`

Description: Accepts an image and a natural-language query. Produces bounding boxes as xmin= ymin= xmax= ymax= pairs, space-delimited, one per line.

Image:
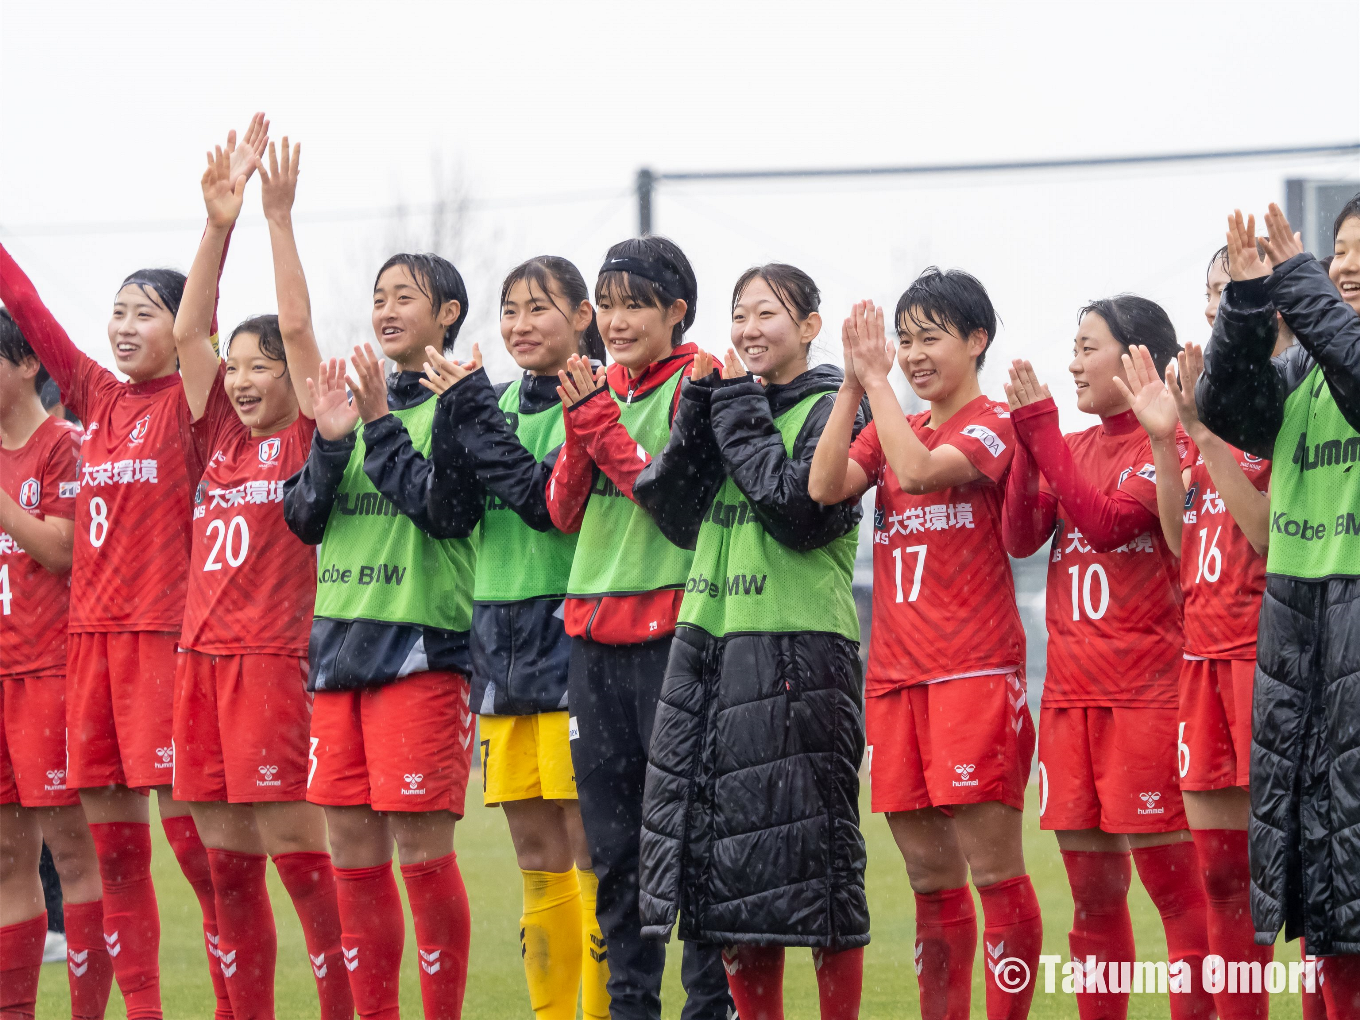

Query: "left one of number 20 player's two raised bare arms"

xmin=174 ymin=113 xmax=267 ymax=420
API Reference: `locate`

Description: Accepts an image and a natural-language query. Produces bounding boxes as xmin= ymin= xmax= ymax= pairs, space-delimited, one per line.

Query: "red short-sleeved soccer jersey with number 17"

xmin=850 ymin=397 xmax=1024 ymax=696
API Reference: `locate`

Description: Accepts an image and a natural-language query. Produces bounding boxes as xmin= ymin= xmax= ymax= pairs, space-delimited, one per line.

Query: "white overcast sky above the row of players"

xmin=0 ymin=0 xmax=1360 ymax=428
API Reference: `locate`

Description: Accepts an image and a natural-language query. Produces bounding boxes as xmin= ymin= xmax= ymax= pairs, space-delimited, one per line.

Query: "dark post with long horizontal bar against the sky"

xmin=638 ymin=141 xmax=1360 ymax=234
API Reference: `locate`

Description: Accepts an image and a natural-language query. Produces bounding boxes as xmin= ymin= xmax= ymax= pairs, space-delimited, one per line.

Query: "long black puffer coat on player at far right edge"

xmin=1195 ymin=254 xmax=1360 ymax=956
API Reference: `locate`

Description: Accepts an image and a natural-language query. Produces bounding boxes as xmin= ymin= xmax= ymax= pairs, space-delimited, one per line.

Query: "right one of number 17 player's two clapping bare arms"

xmin=847 ymin=301 xmax=982 ymax=496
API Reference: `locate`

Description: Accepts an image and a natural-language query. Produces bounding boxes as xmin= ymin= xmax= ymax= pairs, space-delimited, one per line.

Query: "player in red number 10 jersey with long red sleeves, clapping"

xmin=1005 ymin=295 xmax=1213 ymax=1020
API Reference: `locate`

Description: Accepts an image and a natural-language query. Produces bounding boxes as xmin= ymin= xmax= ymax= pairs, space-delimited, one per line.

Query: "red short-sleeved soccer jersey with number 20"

xmin=180 ymin=394 xmax=317 ymax=656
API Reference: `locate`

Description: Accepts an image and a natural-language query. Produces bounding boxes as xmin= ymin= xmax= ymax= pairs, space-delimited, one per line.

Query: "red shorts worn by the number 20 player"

xmin=174 ymin=650 xmax=311 ymax=804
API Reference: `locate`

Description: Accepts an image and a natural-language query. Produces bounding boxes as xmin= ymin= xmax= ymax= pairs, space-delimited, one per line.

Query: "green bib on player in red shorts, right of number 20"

xmin=317 ymin=394 xmax=477 ymax=631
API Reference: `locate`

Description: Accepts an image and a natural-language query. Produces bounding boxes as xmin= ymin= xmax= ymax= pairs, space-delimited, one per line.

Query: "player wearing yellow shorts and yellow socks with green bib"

xmin=413 ymin=256 xmax=609 ymax=1020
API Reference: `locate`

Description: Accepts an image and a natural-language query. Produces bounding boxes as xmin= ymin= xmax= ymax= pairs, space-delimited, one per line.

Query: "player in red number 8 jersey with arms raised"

xmin=0 ymin=114 xmax=268 ymax=1020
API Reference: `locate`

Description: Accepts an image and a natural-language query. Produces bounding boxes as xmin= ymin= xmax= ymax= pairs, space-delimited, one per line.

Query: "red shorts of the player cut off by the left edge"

xmin=0 ymin=673 xmax=80 ymax=808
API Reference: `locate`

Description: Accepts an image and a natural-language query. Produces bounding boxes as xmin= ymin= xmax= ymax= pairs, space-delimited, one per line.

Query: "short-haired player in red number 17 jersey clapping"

xmin=808 ymin=267 xmax=1043 ymax=1020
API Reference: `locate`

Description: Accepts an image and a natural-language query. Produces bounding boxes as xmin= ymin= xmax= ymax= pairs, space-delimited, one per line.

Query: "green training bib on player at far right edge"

xmin=1266 ymin=364 xmax=1360 ymax=579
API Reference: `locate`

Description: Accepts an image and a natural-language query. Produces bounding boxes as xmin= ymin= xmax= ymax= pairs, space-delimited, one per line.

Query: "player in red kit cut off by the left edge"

xmin=0 ymin=310 xmax=113 ymax=1017
